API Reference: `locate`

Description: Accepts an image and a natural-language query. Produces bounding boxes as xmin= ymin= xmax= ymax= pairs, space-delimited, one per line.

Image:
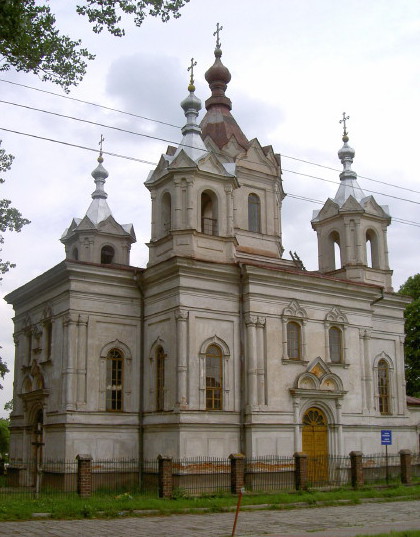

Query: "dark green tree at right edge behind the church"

xmin=398 ymin=274 xmax=420 ymax=397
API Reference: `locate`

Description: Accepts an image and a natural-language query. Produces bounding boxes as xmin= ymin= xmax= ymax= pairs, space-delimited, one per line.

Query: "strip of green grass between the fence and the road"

xmin=0 ymin=484 xmax=420 ymax=520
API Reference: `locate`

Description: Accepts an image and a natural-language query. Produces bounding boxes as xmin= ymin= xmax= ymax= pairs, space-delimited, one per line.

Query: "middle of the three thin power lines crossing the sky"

xmin=0 ymin=99 xmax=420 ymax=205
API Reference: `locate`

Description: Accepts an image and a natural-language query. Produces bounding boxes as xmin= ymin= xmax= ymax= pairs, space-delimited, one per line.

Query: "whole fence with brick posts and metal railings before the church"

xmin=0 ymin=450 xmax=420 ymax=497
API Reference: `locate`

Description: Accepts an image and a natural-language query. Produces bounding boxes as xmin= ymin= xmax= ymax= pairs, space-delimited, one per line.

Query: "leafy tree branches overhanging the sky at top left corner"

xmin=0 ymin=0 xmax=189 ymax=92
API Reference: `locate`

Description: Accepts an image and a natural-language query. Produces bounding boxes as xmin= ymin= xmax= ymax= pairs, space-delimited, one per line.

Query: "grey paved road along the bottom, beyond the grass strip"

xmin=0 ymin=501 xmax=420 ymax=537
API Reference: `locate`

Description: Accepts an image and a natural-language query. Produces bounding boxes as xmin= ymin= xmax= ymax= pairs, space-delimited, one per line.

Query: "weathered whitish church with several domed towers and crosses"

xmin=6 ymin=40 xmax=420 ymax=461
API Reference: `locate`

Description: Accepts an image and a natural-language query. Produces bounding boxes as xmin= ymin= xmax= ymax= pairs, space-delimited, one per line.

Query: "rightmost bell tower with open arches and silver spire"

xmin=311 ymin=114 xmax=392 ymax=291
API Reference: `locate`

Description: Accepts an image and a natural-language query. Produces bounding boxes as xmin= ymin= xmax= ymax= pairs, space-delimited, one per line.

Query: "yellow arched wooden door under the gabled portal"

xmin=302 ymin=407 xmax=328 ymax=483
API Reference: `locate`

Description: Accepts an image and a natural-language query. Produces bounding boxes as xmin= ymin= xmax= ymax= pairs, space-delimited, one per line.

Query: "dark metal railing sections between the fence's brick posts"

xmin=0 ymin=453 xmax=420 ymax=497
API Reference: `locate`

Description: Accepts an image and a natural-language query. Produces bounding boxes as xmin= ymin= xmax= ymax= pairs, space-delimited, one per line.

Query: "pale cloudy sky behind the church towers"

xmin=0 ymin=0 xmax=420 ymax=416
